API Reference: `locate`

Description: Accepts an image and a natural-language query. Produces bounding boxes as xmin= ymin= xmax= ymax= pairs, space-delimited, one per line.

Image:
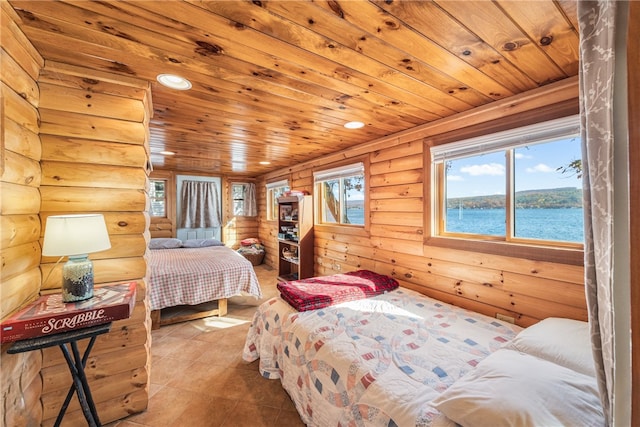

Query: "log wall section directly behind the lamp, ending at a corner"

xmin=39 ymin=62 xmax=151 ymax=426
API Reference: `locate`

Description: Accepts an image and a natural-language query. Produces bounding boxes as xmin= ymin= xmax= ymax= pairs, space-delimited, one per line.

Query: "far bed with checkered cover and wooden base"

xmin=149 ymin=239 xmax=262 ymax=329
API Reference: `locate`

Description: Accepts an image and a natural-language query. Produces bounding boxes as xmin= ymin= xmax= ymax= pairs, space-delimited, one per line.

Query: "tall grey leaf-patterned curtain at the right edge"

xmin=578 ymin=0 xmax=616 ymax=425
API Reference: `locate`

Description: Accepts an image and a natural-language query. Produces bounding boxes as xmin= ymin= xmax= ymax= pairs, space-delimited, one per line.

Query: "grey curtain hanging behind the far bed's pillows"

xmin=180 ymin=181 xmax=221 ymax=228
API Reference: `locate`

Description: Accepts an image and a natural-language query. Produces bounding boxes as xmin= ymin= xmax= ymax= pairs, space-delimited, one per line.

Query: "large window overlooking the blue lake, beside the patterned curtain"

xmin=431 ymin=116 xmax=584 ymax=247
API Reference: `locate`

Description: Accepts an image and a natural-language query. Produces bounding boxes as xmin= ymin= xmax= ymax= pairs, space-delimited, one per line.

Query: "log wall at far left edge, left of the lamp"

xmin=0 ymin=1 xmax=44 ymax=427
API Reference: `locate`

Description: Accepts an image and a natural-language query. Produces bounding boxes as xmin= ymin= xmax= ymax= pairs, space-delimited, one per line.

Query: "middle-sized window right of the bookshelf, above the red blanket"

xmin=313 ymin=162 xmax=365 ymax=226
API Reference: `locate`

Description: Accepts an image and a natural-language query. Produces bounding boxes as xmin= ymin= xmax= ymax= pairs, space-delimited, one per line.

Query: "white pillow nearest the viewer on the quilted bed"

xmin=431 ymin=349 xmax=604 ymax=427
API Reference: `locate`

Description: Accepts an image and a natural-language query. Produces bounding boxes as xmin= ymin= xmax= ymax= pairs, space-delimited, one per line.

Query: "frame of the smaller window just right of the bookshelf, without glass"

xmin=313 ymin=159 xmax=369 ymax=232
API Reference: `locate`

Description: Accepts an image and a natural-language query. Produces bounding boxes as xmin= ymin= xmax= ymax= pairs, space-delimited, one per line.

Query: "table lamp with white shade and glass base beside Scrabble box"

xmin=42 ymin=214 xmax=111 ymax=302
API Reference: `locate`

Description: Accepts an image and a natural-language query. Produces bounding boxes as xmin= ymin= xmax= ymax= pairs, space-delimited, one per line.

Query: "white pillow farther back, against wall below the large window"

xmin=504 ymin=317 xmax=595 ymax=376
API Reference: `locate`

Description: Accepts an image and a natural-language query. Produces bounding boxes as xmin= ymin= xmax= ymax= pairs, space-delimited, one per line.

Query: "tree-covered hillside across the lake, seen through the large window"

xmin=447 ymin=187 xmax=582 ymax=209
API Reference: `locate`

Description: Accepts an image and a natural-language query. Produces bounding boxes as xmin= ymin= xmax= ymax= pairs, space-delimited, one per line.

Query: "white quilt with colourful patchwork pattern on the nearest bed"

xmin=243 ymin=288 xmax=521 ymax=427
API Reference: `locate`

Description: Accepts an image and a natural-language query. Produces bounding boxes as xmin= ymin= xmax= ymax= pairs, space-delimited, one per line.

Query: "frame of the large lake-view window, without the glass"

xmin=425 ymin=115 xmax=584 ymax=252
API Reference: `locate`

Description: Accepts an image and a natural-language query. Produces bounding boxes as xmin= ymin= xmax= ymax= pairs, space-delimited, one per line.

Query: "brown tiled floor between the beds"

xmin=107 ymin=265 xmax=304 ymax=427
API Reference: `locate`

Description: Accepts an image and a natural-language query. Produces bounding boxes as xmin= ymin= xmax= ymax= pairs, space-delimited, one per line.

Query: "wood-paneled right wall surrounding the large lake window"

xmin=258 ymin=79 xmax=587 ymax=326
